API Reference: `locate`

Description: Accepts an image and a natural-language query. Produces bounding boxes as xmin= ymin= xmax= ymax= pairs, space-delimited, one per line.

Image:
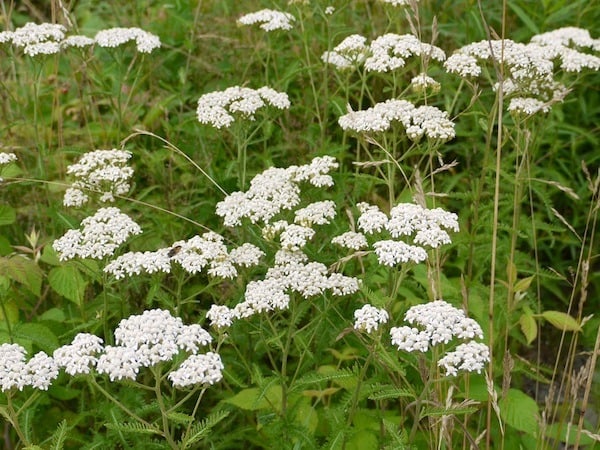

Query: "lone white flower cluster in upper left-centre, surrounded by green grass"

xmin=196 ymin=86 xmax=290 ymax=128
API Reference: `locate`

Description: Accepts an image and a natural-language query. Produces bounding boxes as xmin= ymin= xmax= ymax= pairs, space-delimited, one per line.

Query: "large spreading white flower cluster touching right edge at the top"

xmin=445 ymin=27 xmax=600 ymax=115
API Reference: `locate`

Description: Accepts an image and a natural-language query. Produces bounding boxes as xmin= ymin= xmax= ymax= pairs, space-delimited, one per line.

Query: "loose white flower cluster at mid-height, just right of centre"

xmin=331 ymin=202 xmax=459 ymax=267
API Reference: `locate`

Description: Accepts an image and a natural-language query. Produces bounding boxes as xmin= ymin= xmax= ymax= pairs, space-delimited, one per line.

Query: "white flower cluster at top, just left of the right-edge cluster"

xmin=321 ymin=33 xmax=446 ymax=73
